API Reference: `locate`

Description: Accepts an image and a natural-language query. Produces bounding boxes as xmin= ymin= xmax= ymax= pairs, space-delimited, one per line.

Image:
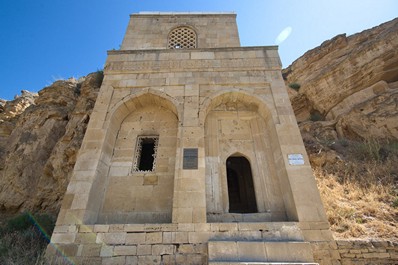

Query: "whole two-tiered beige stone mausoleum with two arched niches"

xmin=47 ymin=12 xmax=334 ymax=265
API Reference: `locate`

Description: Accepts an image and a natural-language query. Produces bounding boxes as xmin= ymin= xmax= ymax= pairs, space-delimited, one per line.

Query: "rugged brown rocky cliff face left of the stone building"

xmin=0 ymin=73 xmax=103 ymax=212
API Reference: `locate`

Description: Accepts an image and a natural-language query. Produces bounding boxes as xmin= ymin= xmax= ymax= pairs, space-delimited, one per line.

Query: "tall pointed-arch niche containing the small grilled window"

xmin=97 ymin=93 xmax=178 ymax=224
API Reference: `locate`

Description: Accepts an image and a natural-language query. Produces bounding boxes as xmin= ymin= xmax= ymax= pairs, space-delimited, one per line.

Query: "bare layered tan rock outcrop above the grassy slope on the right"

xmin=283 ymin=18 xmax=398 ymax=139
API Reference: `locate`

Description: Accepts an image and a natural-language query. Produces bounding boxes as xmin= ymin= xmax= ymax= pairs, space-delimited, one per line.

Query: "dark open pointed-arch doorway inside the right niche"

xmin=227 ymin=156 xmax=257 ymax=213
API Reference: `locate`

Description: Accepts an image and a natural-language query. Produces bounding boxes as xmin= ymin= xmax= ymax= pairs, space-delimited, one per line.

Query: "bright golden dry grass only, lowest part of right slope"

xmin=315 ymin=170 xmax=398 ymax=239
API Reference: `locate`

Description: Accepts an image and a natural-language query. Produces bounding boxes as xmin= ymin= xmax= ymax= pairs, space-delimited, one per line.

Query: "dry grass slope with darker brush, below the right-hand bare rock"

xmin=310 ymin=138 xmax=398 ymax=240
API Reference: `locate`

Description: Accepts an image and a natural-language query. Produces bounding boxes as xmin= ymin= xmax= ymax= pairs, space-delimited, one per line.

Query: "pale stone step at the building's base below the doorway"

xmin=208 ymin=241 xmax=314 ymax=265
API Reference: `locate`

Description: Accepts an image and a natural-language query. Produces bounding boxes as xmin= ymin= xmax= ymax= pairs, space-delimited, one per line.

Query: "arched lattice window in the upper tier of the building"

xmin=168 ymin=27 xmax=196 ymax=49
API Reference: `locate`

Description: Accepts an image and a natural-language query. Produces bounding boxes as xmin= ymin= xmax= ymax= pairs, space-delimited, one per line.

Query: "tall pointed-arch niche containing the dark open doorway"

xmin=204 ymin=92 xmax=287 ymax=222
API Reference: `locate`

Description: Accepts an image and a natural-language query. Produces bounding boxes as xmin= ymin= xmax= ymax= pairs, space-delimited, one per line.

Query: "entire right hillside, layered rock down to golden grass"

xmin=283 ymin=19 xmax=398 ymax=239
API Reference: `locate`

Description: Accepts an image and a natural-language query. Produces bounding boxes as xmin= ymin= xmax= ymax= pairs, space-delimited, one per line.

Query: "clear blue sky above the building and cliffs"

xmin=0 ymin=0 xmax=398 ymax=100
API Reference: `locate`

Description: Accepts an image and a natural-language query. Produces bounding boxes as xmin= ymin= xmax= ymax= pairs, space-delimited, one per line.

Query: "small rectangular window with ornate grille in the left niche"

xmin=133 ymin=136 xmax=159 ymax=172
